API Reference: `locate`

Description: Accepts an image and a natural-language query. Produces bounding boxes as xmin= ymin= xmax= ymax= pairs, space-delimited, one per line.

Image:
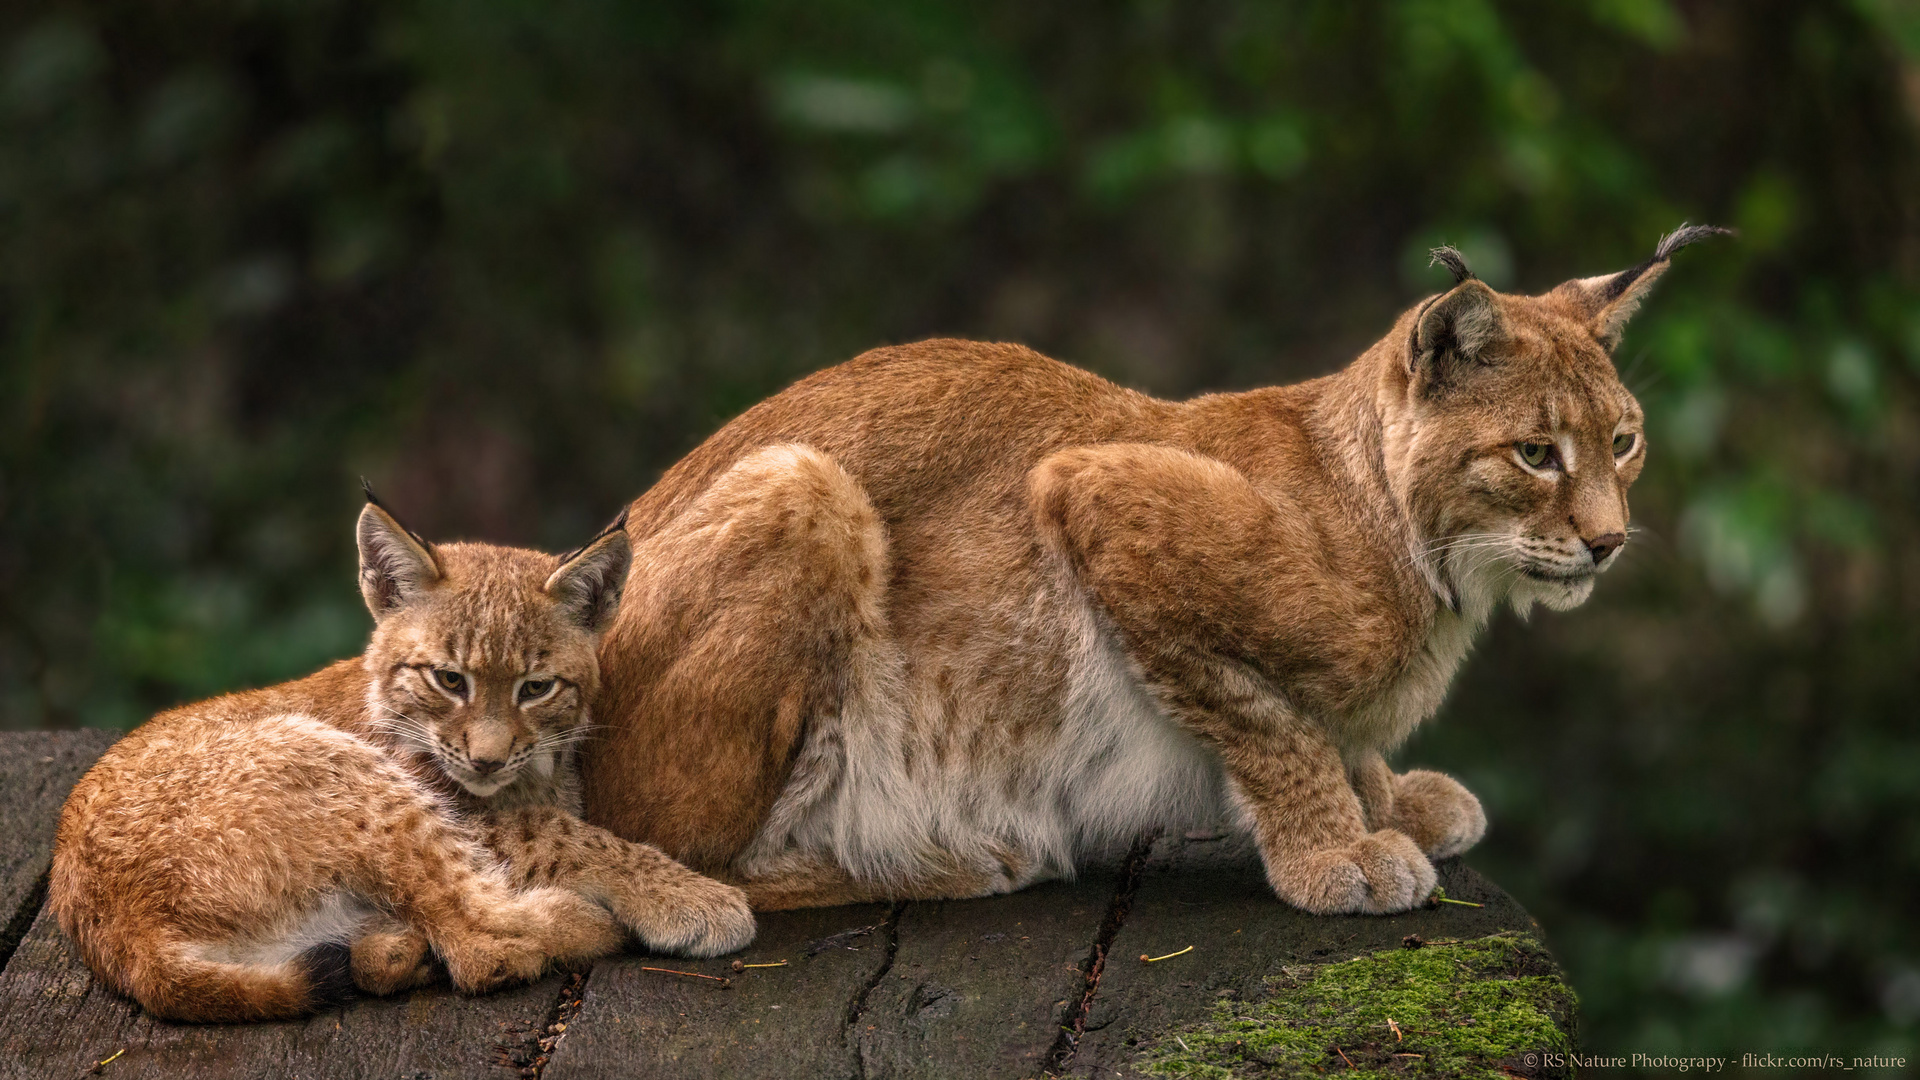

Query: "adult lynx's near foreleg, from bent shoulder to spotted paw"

xmin=1029 ymin=444 xmax=1434 ymax=913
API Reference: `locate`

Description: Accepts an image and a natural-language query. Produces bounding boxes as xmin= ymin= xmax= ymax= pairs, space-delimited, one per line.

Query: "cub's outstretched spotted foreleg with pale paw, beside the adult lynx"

xmin=482 ymin=807 xmax=753 ymax=957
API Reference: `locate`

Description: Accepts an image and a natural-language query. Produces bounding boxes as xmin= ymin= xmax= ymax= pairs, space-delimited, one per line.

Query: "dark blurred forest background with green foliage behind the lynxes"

xmin=0 ymin=0 xmax=1920 ymax=1059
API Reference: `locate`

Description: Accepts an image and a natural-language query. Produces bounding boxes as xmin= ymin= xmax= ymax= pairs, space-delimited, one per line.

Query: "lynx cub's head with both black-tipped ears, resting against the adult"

xmin=359 ymin=503 xmax=628 ymax=798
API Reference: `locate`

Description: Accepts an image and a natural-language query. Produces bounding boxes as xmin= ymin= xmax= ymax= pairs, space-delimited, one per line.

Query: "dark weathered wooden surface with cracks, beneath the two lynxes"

xmin=0 ymin=732 xmax=1566 ymax=1080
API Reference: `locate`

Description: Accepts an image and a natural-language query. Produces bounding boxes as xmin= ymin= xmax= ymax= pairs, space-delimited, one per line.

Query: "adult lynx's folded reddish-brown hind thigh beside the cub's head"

xmin=582 ymin=444 xmax=893 ymax=872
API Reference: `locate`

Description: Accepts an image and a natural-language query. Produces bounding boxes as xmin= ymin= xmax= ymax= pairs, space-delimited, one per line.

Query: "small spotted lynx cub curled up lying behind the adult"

xmin=48 ymin=492 xmax=753 ymax=1020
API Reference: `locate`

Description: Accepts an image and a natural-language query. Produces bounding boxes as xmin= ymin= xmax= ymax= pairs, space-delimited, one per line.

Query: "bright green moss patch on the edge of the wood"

xmin=1140 ymin=934 xmax=1574 ymax=1080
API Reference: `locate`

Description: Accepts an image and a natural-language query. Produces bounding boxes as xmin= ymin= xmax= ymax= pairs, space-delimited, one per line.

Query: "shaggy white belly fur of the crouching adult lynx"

xmin=735 ymin=601 xmax=1227 ymax=892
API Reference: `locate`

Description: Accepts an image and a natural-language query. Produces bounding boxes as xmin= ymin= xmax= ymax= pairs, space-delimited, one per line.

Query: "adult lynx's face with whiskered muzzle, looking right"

xmin=1402 ymin=272 xmax=1647 ymax=613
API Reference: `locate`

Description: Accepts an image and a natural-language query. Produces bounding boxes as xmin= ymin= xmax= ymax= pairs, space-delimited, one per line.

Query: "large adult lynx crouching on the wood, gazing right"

xmin=586 ymin=227 xmax=1718 ymax=913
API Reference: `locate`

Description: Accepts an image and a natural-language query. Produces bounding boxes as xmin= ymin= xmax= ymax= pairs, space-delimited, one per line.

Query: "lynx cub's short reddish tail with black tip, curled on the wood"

xmin=121 ymin=944 xmax=353 ymax=1022
